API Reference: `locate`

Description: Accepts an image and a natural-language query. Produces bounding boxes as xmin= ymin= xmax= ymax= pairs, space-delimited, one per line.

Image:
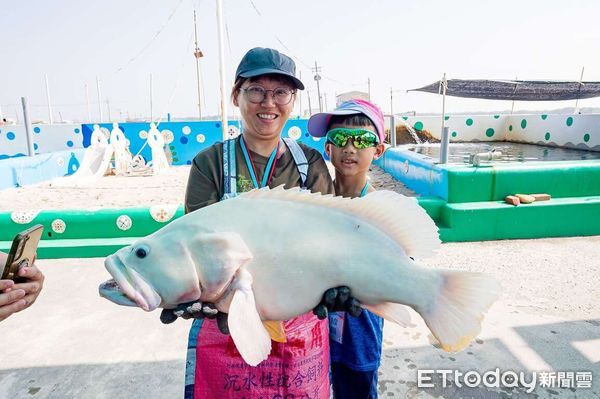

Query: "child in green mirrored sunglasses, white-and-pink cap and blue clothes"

xmin=308 ymin=100 xmax=385 ymax=399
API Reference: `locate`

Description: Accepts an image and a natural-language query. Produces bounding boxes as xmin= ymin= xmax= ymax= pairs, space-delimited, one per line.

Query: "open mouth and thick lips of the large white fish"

xmin=98 ymin=255 xmax=162 ymax=312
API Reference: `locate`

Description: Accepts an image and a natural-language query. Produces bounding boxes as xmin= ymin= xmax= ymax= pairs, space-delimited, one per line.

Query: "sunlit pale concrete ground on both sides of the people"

xmin=0 ymin=236 xmax=600 ymax=399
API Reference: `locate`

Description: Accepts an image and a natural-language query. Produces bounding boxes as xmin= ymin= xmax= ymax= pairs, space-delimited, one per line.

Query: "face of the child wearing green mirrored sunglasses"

xmin=325 ymin=124 xmax=384 ymax=177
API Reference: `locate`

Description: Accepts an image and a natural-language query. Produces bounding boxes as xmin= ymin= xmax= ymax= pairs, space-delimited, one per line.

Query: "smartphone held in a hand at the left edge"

xmin=2 ymin=224 xmax=44 ymax=281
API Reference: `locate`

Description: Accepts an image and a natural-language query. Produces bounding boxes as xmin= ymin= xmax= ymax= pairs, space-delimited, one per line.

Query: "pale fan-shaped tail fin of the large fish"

xmin=419 ymin=271 xmax=500 ymax=352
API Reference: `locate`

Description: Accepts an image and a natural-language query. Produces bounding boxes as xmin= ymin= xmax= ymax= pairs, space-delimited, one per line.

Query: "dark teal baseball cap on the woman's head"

xmin=235 ymin=47 xmax=304 ymax=90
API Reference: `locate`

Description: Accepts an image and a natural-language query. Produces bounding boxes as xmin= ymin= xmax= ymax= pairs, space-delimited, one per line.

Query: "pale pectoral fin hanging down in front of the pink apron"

xmin=227 ymin=269 xmax=271 ymax=366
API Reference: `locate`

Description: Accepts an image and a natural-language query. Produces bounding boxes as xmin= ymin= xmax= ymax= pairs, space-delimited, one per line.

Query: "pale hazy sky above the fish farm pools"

xmin=0 ymin=0 xmax=600 ymax=122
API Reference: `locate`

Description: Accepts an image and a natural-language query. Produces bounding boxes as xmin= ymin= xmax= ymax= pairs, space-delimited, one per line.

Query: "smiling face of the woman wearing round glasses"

xmin=233 ymin=76 xmax=296 ymax=140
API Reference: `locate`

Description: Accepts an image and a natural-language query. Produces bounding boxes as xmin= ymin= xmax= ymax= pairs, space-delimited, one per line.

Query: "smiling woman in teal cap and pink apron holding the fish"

xmin=180 ymin=48 xmax=333 ymax=399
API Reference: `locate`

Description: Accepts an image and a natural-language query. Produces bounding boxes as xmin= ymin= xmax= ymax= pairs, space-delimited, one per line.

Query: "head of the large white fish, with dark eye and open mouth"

xmin=100 ymin=226 xmax=252 ymax=311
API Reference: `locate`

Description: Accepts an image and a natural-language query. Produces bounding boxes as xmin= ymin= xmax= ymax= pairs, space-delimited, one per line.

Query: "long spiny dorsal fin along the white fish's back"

xmin=238 ymin=186 xmax=440 ymax=258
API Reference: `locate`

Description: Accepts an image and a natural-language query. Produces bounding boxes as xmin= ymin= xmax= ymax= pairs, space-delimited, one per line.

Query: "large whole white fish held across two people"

xmin=100 ymin=188 xmax=498 ymax=365
